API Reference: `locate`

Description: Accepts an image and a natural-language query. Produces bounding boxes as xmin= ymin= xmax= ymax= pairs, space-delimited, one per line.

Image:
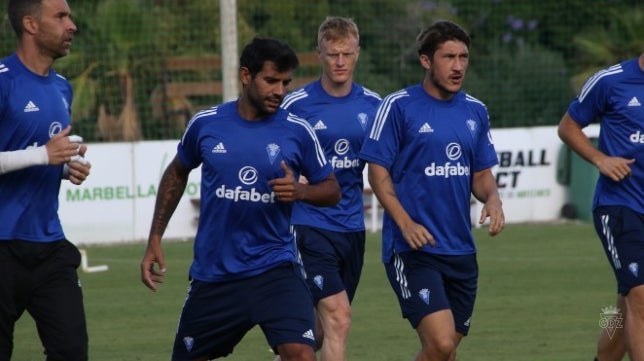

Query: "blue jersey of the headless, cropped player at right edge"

xmin=568 ymin=59 xmax=644 ymax=214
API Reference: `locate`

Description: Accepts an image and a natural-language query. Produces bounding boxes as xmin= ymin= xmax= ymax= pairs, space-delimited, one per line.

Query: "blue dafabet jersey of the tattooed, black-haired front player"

xmin=177 ymin=101 xmax=333 ymax=282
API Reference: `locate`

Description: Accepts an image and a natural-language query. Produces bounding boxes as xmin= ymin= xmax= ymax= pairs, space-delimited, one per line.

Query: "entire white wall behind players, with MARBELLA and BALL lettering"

xmin=59 ymin=126 xmax=598 ymax=244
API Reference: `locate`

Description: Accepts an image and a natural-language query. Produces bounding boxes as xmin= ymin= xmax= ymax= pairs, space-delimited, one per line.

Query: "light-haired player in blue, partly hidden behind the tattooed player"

xmin=282 ymin=17 xmax=381 ymax=361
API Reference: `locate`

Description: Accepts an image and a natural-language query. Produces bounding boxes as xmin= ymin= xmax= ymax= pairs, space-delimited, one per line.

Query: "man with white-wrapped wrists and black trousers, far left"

xmin=0 ymin=0 xmax=91 ymax=361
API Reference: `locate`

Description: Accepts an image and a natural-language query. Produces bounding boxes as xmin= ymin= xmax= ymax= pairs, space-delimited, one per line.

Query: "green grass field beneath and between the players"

xmin=13 ymin=223 xmax=615 ymax=361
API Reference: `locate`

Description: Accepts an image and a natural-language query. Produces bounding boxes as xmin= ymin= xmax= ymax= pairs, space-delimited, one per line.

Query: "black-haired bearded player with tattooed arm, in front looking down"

xmin=141 ymin=38 xmax=340 ymax=361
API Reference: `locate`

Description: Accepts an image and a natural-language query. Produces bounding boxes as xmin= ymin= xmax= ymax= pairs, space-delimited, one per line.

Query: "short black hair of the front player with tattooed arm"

xmin=239 ymin=37 xmax=300 ymax=77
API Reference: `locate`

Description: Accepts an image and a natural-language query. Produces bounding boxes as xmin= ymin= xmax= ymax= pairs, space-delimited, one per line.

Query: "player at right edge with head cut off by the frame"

xmin=558 ymin=53 xmax=644 ymax=361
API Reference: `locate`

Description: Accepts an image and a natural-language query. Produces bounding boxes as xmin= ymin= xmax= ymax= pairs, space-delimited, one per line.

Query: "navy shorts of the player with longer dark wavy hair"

xmin=385 ymin=251 xmax=478 ymax=335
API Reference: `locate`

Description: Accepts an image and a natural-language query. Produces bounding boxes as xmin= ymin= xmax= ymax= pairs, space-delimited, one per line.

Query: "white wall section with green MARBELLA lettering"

xmin=59 ymin=141 xmax=201 ymax=244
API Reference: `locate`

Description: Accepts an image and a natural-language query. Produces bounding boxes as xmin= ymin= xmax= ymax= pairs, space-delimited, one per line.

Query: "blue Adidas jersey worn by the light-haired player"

xmin=282 ymin=80 xmax=381 ymax=232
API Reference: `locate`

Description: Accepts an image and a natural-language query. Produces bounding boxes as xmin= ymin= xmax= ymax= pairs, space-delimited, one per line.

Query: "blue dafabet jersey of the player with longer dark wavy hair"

xmin=360 ymin=85 xmax=498 ymax=262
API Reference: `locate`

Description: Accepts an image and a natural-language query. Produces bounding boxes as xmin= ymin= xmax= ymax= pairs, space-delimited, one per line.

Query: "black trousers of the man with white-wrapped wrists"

xmin=0 ymin=240 xmax=88 ymax=361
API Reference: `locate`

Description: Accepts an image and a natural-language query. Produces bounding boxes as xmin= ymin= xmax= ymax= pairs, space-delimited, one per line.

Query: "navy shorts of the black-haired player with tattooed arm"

xmin=172 ymin=263 xmax=315 ymax=361
